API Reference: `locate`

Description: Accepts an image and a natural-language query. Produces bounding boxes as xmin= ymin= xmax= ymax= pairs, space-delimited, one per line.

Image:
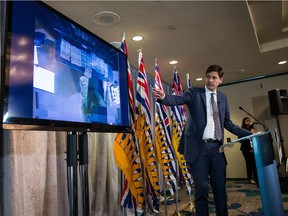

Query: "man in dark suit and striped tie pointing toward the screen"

xmin=153 ymin=65 xmax=251 ymax=216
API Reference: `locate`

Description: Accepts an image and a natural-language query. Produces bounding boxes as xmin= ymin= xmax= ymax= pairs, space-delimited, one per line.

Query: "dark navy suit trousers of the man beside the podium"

xmin=189 ymin=142 xmax=228 ymax=216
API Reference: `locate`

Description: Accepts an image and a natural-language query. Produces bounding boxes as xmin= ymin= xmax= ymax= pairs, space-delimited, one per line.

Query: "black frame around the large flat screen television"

xmin=1 ymin=1 xmax=131 ymax=132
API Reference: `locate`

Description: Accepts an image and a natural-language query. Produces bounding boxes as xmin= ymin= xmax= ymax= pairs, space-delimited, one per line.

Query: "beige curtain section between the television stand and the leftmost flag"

xmin=89 ymin=133 xmax=121 ymax=215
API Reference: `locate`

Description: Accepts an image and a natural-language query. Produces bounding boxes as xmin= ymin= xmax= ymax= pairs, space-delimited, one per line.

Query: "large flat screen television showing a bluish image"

xmin=1 ymin=1 xmax=131 ymax=132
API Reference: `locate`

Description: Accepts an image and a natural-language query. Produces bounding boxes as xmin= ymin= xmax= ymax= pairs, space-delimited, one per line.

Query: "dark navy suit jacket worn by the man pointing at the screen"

xmin=159 ymin=88 xmax=252 ymax=163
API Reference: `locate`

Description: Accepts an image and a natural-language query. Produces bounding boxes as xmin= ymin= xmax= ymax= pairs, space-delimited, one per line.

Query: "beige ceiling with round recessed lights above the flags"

xmin=44 ymin=0 xmax=288 ymax=89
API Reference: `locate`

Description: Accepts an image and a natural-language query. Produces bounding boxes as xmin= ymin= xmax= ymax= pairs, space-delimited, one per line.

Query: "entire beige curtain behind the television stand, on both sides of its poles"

xmin=1 ymin=130 xmax=121 ymax=216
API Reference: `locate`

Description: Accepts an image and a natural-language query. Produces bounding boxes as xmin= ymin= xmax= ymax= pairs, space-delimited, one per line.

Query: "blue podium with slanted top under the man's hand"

xmin=220 ymin=131 xmax=285 ymax=216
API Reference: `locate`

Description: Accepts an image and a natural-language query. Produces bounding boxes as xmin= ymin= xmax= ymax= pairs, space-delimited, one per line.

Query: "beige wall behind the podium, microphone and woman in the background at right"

xmin=219 ymin=74 xmax=288 ymax=178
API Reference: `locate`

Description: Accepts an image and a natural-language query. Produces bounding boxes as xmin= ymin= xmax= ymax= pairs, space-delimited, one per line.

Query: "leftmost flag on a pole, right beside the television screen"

xmin=113 ymin=33 xmax=145 ymax=210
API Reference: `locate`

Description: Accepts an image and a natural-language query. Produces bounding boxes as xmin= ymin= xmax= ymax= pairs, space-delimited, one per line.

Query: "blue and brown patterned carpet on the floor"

xmin=160 ymin=180 xmax=288 ymax=216
